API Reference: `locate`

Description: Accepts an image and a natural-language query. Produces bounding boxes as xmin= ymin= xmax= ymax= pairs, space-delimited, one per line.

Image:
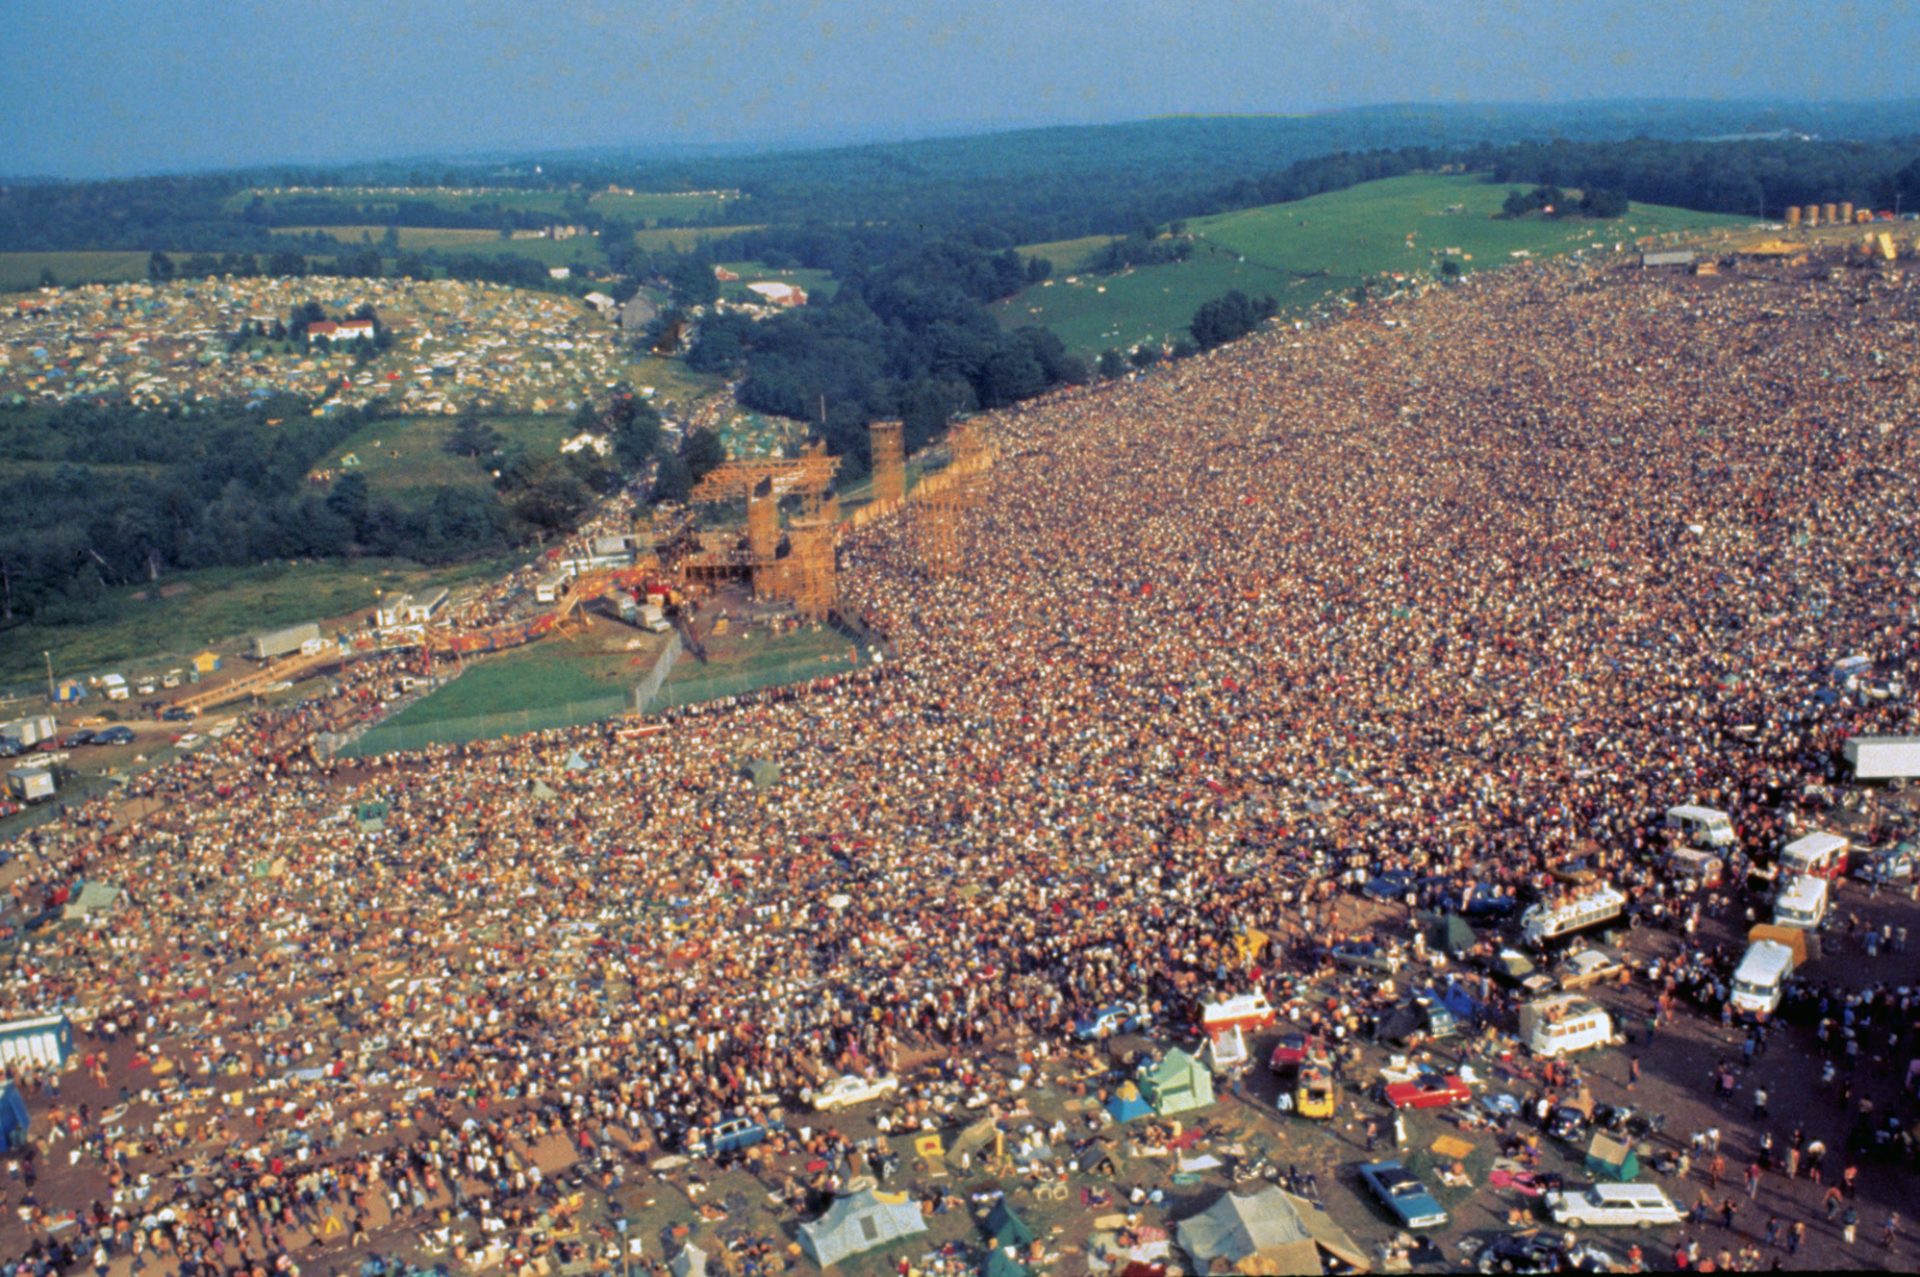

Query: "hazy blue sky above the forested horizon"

xmin=0 ymin=0 xmax=1920 ymax=177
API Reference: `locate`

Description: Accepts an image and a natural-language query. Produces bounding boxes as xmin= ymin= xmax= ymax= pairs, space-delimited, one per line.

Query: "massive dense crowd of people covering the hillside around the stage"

xmin=8 ymin=253 xmax=1920 ymax=1271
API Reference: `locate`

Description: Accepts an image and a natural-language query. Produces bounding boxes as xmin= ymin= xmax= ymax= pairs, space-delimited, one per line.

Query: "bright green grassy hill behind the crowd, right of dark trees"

xmin=995 ymin=177 xmax=1747 ymax=353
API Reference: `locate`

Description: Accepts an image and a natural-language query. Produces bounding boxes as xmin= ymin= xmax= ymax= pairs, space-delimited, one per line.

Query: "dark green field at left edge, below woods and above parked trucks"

xmin=0 ymin=559 xmax=515 ymax=689
